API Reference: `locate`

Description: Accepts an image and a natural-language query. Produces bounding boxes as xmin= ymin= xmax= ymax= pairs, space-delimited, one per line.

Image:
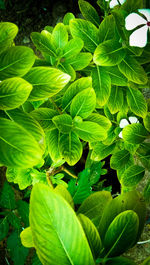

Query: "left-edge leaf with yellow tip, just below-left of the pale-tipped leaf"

xmin=0 ymin=77 xmax=32 ymax=110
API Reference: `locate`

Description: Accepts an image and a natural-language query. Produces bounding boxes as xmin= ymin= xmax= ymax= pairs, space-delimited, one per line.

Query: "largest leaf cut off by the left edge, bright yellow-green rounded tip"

xmin=0 ymin=118 xmax=43 ymax=168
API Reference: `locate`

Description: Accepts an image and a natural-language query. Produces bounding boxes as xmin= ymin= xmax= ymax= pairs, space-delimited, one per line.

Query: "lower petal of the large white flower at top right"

xmin=129 ymin=25 xmax=148 ymax=48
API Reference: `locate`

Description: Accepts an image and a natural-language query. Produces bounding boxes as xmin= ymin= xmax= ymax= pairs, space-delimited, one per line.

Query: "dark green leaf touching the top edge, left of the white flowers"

xmin=79 ymin=0 xmax=100 ymax=26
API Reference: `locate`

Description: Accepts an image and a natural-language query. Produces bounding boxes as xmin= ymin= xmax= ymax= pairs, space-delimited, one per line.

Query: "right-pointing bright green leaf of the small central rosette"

xmin=74 ymin=121 xmax=107 ymax=142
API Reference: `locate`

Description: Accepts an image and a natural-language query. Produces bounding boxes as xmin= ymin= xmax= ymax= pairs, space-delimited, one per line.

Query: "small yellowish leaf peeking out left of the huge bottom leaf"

xmin=20 ymin=226 xmax=34 ymax=248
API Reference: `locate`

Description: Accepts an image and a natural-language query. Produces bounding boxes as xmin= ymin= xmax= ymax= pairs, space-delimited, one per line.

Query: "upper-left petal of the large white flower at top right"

xmin=125 ymin=13 xmax=147 ymax=30
